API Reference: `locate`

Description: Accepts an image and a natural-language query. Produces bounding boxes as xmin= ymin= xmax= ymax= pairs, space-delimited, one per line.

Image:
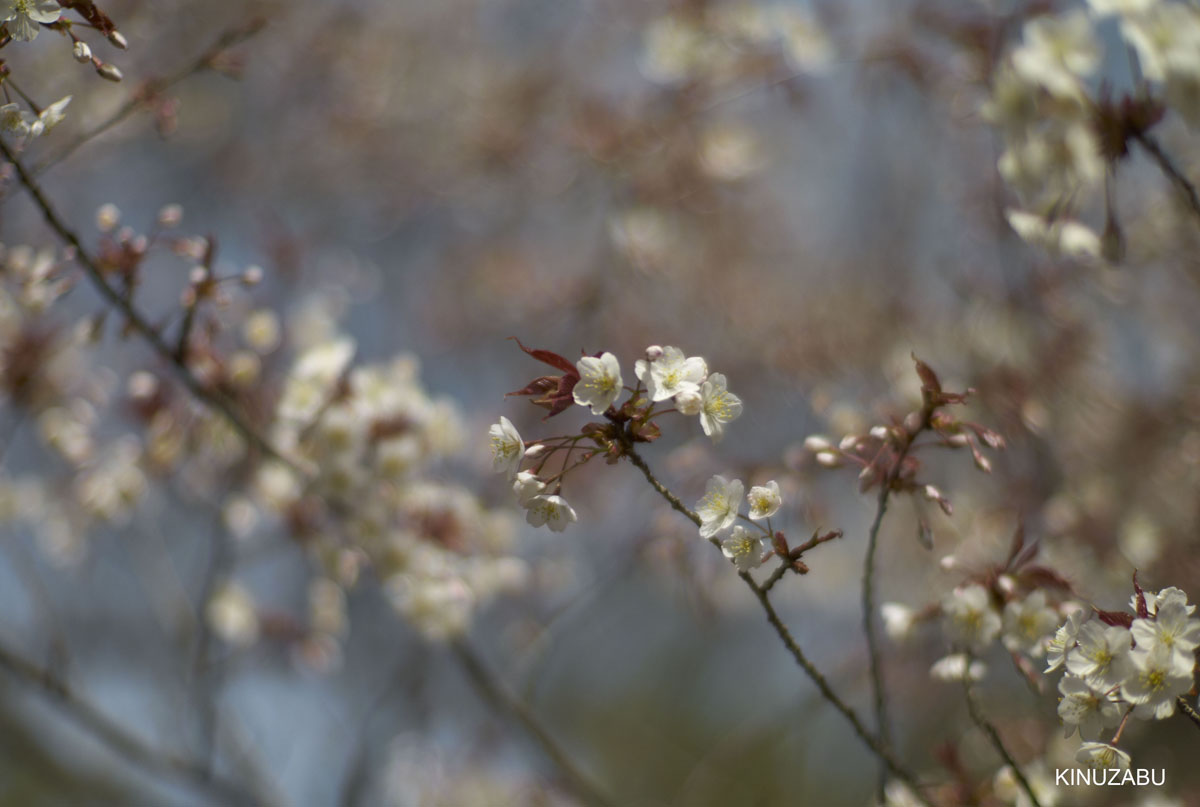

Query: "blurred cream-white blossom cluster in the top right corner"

xmin=983 ymin=0 xmax=1200 ymax=259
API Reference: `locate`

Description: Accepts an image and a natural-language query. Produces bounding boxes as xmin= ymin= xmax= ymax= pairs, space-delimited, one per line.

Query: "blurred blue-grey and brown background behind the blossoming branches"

xmin=0 ymin=0 xmax=1200 ymax=807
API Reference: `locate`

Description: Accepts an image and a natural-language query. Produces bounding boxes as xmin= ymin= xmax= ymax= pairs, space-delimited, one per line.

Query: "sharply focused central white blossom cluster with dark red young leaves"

xmin=488 ymin=345 xmax=742 ymax=532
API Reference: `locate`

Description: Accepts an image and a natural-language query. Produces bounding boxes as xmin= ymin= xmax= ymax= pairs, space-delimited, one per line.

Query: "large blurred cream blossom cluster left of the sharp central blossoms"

xmin=238 ymin=333 xmax=528 ymax=639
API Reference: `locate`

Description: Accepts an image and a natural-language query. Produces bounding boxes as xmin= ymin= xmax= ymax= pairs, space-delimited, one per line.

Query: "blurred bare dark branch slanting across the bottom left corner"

xmin=0 ymin=645 xmax=259 ymax=805
